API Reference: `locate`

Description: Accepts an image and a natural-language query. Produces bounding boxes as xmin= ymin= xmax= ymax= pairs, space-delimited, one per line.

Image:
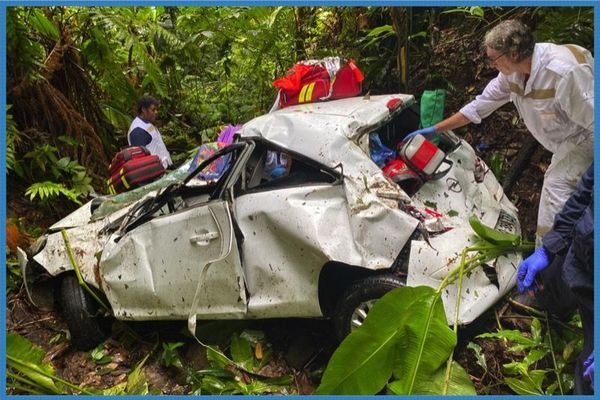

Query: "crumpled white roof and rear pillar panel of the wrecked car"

xmin=241 ymin=95 xmax=418 ymax=269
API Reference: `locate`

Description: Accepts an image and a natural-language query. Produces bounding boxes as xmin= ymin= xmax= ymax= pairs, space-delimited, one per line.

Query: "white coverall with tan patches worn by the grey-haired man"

xmin=460 ymin=43 xmax=594 ymax=245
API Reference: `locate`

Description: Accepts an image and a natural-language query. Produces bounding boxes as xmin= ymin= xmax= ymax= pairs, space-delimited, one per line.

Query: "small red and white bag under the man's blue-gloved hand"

xmin=399 ymin=135 xmax=452 ymax=181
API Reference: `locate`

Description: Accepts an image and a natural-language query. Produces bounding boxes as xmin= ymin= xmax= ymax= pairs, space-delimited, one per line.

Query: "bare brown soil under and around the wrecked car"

xmin=7 ymin=282 xmax=552 ymax=395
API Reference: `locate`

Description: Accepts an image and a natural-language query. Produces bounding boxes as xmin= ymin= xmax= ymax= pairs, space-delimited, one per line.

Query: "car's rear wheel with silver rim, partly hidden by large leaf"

xmin=333 ymin=275 xmax=405 ymax=342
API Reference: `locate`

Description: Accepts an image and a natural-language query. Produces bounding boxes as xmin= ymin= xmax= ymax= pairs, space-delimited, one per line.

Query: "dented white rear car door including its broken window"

xmin=234 ymin=144 xmax=346 ymax=318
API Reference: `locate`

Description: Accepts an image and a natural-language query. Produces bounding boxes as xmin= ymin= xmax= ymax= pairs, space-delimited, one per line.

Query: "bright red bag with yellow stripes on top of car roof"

xmin=273 ymin=57 xmax=364 ymax=108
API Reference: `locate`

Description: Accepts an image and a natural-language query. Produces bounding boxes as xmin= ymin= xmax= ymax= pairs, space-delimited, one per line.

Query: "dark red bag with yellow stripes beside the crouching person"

xmin=107 ymin=150 xmax=165 ymax=194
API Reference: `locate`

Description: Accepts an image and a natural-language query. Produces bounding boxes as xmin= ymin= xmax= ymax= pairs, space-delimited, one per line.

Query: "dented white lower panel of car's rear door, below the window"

xmin=234 ymin=184 xmax=362 ymax=318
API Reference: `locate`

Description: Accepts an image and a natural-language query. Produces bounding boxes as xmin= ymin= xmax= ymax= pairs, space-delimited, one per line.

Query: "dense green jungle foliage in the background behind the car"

xmin=7 ymin=6 xmax=593 ymax=205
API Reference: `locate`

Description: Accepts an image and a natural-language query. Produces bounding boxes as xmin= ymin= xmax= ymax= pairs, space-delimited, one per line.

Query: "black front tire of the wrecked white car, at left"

xmin=60 ymin=274 xmax=106 ymax=350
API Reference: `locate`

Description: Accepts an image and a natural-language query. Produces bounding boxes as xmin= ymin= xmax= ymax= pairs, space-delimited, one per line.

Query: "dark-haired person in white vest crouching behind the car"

xmin=127 ymin=96 xmax=173 ymax=168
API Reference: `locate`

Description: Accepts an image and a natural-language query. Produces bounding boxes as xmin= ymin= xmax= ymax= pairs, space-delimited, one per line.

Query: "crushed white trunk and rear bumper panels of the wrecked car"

xmin=407 ymin=141 xmax=521 ymax=324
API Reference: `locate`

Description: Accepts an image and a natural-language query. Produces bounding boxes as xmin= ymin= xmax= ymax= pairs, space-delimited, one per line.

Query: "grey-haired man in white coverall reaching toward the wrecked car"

xmin=408 ymin=20 xmax=594 ymax=246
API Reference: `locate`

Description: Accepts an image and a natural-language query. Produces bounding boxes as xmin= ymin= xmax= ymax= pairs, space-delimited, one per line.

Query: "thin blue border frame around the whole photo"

xmin=0 ymin=0 xmax=600 ymax=399
